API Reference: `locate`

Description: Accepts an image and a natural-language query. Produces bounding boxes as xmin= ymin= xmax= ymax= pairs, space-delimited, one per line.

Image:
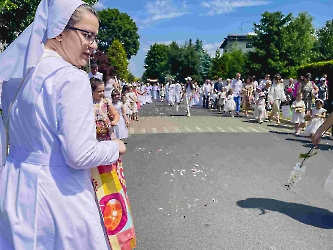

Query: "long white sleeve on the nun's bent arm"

xmin=56 ymin=69 xmax=119 ymax=169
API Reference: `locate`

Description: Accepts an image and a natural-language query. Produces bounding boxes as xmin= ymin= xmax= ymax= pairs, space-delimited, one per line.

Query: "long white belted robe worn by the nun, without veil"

xmin=0 ymin=50 xmax=119 ymax=250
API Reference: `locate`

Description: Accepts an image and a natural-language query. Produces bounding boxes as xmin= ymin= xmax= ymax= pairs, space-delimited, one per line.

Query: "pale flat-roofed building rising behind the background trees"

xmin=220 ymin=35 xmax=253 ymax=53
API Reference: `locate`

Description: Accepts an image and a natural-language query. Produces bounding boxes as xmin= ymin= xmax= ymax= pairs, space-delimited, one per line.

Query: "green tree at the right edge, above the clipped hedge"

xmin=316 ymin=20 xmax=333 ymax=61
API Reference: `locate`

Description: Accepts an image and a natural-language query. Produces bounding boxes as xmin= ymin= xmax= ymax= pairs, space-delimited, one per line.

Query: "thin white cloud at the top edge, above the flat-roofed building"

xmin=201 ymin=0 xmax=270 ymax=16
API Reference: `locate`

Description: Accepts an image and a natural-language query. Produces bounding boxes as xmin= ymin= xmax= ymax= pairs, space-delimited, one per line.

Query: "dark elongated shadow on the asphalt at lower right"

xmin=237 ymin=198 xmax=333 ymax=229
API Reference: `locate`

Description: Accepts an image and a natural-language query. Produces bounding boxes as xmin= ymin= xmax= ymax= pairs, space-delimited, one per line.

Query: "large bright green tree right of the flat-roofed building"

xmin=247 ymin=12 xmax=315 ymax=77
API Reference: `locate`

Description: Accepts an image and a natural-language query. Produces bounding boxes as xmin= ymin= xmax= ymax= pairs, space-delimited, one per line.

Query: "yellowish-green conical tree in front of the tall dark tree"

xmin=106 ymin=39 xmax=128 ymax=80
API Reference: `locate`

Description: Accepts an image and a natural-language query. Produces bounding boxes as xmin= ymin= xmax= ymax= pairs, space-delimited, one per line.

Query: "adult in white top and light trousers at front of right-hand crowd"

xmin=268 ymin=74 xmax=286 ymax=124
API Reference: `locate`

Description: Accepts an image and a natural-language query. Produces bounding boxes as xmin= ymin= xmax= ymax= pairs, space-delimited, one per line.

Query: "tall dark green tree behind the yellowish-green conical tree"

xmin=98 ymin=8 xmax=140 ymax=59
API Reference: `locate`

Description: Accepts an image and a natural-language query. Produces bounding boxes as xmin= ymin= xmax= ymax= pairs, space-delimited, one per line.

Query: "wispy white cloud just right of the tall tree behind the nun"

xmin=141 ymin=0 xmax=188 ymax=28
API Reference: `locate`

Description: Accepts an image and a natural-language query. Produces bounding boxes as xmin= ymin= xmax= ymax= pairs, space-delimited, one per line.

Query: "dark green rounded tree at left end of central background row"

xmin=144 ymin=43 xmax=170 ymax=82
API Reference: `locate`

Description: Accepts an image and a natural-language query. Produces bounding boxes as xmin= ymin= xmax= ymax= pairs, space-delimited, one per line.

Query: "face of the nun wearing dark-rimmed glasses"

xmin=59 ymin=12 xmax=99 ymax=67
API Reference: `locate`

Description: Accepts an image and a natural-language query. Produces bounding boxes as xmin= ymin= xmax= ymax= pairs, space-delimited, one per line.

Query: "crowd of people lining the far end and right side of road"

xmin=99 ymin=73 xmax=329 ymax=141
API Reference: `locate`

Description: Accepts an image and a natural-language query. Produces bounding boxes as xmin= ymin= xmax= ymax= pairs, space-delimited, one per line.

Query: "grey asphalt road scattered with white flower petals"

xmin=123 ymin=100 xmax=333 ymax=250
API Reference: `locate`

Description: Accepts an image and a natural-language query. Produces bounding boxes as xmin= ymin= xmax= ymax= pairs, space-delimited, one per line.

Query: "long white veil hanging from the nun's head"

xmin=0 ymin=0 xmax=85 ymax=165
